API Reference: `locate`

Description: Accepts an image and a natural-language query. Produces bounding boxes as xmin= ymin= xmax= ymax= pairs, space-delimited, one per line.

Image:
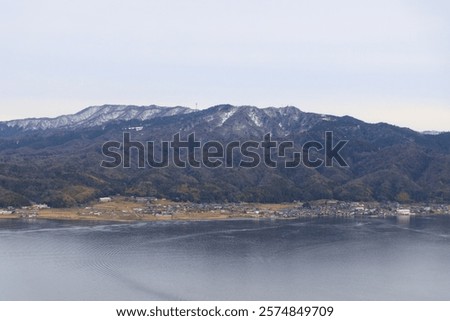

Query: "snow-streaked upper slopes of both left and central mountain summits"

xmin=0 ymin=105 xmax=336 ymax=136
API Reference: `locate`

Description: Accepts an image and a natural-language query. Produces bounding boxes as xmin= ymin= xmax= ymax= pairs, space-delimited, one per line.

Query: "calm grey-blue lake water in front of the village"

xmin=0 ymin=217 xmax=450 ymax=300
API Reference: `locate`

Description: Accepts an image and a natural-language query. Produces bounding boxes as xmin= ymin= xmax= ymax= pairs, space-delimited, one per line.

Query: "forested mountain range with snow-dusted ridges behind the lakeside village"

xmin=0 ymin=105 xmax=450 ymax=207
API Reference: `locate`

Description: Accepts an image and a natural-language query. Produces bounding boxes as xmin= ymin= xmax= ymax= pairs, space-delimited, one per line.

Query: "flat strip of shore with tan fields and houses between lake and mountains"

xmin=0 ymin=197 xmax=450 ymax=222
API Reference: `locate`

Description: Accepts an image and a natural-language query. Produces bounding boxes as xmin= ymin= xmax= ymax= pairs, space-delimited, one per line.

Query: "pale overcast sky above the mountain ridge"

xmin=0 ymin=0 xmax=450 ymax=131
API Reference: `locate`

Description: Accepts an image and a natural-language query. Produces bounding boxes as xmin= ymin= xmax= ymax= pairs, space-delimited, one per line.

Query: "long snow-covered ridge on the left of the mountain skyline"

xmin=0 ymin=105 xmax=194 ymax=130
